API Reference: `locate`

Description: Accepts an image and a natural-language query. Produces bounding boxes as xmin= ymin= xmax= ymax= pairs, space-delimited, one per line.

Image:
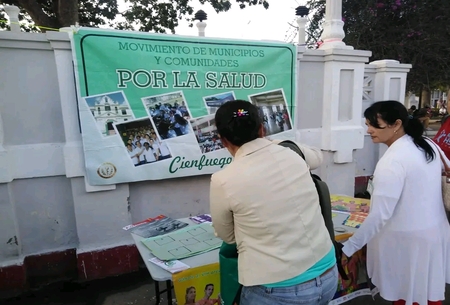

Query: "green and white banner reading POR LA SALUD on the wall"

xmin=71 ymin=28 xmax=296 ymax=185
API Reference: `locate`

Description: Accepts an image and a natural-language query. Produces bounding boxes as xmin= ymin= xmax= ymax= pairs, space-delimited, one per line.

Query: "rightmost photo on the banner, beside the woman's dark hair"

xmin=249 ymin=89 xmax=292 ymax=136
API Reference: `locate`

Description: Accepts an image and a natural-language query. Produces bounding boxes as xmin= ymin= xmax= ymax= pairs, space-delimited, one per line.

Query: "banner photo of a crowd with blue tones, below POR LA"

xmin=142 ymin=91 xmax=192 ymax=140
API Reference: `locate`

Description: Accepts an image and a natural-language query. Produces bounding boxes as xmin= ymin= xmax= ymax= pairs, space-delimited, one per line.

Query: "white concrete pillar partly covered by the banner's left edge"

xmin=46 ymin=28 xmax=133 ymax=264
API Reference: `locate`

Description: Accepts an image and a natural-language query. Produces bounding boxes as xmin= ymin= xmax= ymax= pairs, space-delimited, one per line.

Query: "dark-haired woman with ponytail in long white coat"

xmin=342 ymin=101 xmax=450 ymax=305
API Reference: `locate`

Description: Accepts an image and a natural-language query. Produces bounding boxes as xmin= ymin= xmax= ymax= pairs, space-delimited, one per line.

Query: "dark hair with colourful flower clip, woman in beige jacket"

xmin=215 ymin=100 xmax=262 ymax=146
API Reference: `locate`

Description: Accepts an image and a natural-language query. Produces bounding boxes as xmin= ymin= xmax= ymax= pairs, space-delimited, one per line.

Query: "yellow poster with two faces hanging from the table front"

xmin=172 ymin=263 xmax=221 ymax=305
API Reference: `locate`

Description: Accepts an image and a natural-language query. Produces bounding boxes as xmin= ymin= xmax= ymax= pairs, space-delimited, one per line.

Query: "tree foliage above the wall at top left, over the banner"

xmin=0 ymin=0 xmax=269 ymax=33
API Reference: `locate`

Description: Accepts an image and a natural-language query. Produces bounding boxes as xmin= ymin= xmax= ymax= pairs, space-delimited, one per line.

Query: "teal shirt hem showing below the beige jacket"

xmin=263 ymin=246 xmax=336 ymax=288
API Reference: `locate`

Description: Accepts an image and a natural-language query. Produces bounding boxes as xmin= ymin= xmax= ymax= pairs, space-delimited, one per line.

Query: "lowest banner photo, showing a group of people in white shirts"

xmin=114 ymin=118 xmax=172 ymax=166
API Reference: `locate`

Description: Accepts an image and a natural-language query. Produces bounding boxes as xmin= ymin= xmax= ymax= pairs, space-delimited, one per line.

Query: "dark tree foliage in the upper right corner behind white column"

xmin=307 ymin=0 xmax=450 ymax=92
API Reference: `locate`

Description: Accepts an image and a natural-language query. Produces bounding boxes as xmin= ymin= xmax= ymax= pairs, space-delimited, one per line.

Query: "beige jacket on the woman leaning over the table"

xmin=210 ymin=138 xmax=332 ymax=286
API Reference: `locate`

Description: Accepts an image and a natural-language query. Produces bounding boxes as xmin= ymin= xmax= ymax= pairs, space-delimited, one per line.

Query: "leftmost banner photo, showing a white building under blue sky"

xmin=84 ymin=91 xmax=134 ymax=137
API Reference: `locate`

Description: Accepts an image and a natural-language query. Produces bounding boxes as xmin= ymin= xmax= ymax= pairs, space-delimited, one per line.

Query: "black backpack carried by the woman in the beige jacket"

xmin=278 ymin=140 xmax=348 ymax=280
